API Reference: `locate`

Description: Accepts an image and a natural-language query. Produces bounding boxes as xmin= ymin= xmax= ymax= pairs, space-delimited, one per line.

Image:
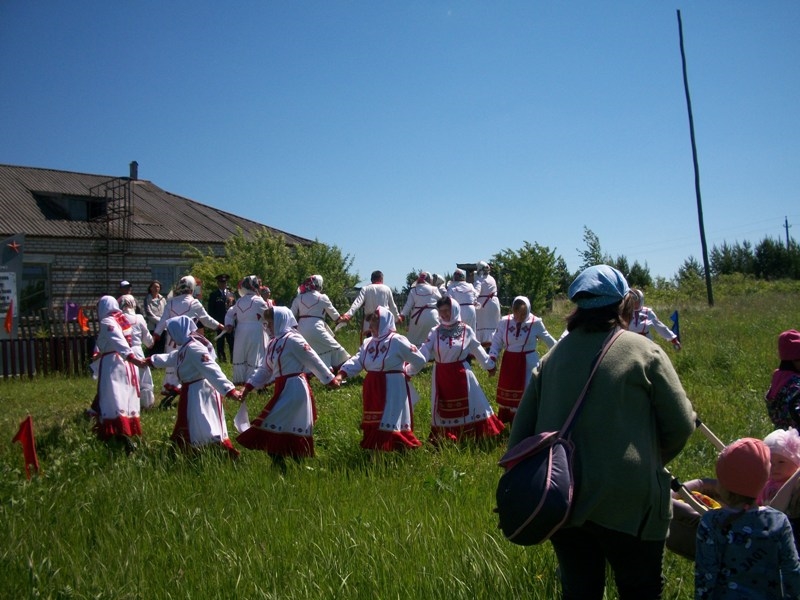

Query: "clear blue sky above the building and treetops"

xmin=0 ymin=0 xmax=800 ymax=287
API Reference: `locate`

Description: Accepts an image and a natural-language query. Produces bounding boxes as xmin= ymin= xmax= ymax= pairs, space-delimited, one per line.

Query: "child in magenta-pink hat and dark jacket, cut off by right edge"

xmin=764 ymin=329 xmax=800 ymax=429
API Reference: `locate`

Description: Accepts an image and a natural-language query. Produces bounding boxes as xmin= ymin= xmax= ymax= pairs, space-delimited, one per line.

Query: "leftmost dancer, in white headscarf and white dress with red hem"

xmin=92 ymin=296 xmax=147 ymax=442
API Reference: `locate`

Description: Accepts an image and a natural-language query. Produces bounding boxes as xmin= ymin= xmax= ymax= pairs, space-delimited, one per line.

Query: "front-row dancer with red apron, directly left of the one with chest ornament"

xmin=336 ymin=306 xmax=427 ymax=451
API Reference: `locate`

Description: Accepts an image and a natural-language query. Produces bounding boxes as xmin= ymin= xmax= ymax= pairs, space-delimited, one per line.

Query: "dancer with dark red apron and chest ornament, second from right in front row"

xmin=409 ymin=296 xmax=504 ymax=443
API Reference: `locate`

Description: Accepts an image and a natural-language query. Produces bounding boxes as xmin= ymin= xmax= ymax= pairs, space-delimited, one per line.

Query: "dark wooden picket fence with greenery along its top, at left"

xmin=0 ymin=307 xmax=98 ymax=379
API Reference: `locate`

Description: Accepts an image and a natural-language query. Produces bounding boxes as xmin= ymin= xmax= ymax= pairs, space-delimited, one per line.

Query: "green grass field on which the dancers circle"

xmin=0 ymin=280 xmax=800 ymax=600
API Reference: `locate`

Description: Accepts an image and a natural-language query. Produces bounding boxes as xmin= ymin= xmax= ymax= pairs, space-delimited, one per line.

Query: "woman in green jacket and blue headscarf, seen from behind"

xmin=509 ymin=265 xmax=695 ymax=600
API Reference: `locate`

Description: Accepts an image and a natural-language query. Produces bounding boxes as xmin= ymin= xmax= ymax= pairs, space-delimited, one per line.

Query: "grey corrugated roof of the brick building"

xmin=0 ymin=165 xmax=312 ymax=244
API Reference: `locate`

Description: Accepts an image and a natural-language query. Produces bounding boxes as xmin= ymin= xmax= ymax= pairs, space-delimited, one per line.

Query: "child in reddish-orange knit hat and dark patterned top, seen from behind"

xmin=695 ymin=438 xmax=800 ymax=600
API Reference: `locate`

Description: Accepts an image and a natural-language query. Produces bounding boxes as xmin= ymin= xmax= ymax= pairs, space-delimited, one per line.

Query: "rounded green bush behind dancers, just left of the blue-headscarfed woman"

xmin=492 ymin=242 xmax=566 ymax=312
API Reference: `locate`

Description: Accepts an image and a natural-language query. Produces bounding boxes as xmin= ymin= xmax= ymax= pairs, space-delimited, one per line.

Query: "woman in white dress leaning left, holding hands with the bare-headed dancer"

xmin=292 ymin=275 xmax=350 ymax=372
